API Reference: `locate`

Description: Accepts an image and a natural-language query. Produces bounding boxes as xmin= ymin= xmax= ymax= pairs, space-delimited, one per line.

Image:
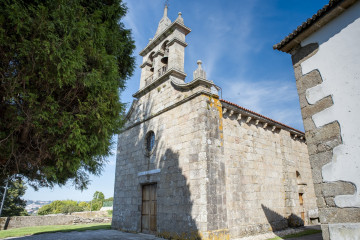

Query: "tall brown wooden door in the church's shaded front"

xmin=141 ymin=184 xmax=156 ymax=233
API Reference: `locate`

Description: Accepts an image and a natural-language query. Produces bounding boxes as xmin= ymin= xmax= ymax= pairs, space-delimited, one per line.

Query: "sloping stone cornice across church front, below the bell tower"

xmin=120 ymin=90 xmax=218 ymax=133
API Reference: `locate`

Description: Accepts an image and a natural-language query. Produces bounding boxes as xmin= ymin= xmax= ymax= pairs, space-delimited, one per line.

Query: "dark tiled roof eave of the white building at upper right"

xmin=273 ymin=0 xmax=358 ymax=53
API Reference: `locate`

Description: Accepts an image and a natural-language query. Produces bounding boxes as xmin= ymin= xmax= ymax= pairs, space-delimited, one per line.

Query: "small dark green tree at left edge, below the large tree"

xmin=0 ymin=180 xmax=28 ymax=217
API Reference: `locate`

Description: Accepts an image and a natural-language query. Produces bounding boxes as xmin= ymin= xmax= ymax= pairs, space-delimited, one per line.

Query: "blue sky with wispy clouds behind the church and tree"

xmin=24 ymin=0 xmax=328 ymax=200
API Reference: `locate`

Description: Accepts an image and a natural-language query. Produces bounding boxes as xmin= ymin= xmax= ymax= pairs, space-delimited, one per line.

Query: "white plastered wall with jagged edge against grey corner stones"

xmin=301 ymin=2 xmax=360 ymax=207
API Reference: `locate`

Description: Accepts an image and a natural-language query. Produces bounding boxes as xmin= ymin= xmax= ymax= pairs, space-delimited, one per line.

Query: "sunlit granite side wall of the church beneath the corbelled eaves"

xmin=224 ymin=114 xmax=316 ymax=237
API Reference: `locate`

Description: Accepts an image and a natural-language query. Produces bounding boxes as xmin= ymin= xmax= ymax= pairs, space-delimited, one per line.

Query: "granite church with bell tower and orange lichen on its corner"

xmin=112 ymin=4 xmax=317 ymax=239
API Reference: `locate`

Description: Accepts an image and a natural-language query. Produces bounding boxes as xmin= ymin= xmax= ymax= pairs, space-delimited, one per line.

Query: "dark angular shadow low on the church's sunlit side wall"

xmin=261 ymin=204 xmax=304 ymax=232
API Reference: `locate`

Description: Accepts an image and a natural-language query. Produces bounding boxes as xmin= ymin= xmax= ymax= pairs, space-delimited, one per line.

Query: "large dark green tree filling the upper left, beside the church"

xmin=0 ymin=0 xmax=134 ymax=189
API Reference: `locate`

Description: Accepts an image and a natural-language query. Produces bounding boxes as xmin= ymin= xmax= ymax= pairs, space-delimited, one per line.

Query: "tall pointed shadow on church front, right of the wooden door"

xmin=157 ymin=148 xmax=201 ymax=240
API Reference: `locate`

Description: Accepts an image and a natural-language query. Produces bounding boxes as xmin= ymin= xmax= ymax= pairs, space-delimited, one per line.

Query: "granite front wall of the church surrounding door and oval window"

xmin=113 ymin=87 xmax=226 ymax=236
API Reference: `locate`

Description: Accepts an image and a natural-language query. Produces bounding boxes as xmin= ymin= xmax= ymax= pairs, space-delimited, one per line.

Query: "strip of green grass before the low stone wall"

xmin=0 ymin=223 xmax=111 ymax=238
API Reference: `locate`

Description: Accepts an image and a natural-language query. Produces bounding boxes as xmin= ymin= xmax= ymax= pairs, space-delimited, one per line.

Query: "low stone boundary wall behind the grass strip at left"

xmin=0 ymin=215 xmax=111 ymax=230
